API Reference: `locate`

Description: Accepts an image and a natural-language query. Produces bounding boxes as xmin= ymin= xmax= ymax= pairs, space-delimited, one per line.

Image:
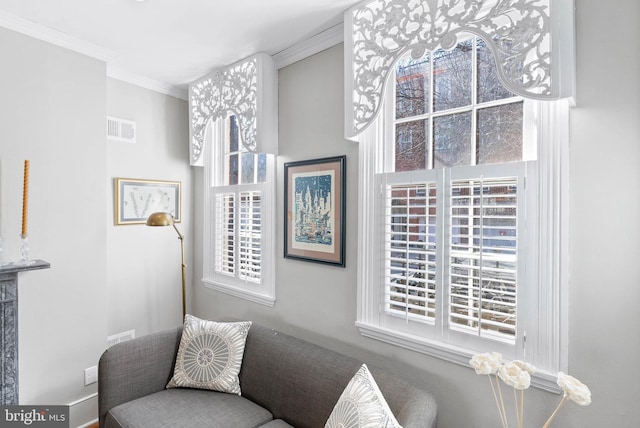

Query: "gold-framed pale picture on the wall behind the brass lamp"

xmin=114 ymin=178 xmax=182 ymax=225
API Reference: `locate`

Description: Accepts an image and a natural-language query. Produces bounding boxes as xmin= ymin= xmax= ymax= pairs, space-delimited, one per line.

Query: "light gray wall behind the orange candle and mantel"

xmin=0 ymin=29 xmax=108 ymax=404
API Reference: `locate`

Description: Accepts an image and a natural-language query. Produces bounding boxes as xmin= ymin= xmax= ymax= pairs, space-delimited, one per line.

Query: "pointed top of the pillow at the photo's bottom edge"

xmin=325 ymin=364 xmax=402 ymax=428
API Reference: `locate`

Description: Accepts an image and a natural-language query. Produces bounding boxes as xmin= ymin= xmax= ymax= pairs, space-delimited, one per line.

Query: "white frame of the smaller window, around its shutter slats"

xmin=202 ymin=118 xmax=276 ymax=307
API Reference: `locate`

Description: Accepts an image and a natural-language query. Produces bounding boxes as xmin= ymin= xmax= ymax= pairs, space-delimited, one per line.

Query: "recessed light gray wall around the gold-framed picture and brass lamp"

xmin=107 ymin=79 xmax=193 ymax=337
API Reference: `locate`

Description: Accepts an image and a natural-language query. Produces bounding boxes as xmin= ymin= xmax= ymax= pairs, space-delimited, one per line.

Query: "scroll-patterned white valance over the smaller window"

xmin=189 ymin=53 xmax=278 ymax=166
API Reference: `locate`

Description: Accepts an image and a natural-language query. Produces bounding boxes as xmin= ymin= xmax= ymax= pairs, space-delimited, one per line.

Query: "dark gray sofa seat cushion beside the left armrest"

xmin=101 ymin=388 xmax=273 ymax=428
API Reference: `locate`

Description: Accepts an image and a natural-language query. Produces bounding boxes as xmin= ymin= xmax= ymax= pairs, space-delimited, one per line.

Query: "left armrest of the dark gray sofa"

xmin=98 ymin=327 xmax=182 ymax=426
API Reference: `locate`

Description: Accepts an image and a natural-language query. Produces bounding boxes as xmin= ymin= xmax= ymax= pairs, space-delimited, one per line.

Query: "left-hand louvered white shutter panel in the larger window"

xmin=384 ymin=182 xmax=436 ymax=321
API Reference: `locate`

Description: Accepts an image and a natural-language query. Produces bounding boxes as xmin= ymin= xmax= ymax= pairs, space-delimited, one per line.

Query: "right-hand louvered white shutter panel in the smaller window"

xmin=239 ymin=192 xmax=262 ymax=283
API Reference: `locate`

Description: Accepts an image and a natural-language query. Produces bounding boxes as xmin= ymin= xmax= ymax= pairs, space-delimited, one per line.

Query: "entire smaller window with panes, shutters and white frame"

xmin=204 ymin=116 xmax=275 ymax=306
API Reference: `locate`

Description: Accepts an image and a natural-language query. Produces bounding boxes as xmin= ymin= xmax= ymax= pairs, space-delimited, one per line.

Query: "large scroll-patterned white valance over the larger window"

xmin=345 ymin=0 xmax=575 ymax=138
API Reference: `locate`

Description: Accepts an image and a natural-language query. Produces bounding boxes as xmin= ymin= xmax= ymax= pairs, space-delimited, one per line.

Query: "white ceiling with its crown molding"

xmin=0 ymin=0 xmax=360 ymax=98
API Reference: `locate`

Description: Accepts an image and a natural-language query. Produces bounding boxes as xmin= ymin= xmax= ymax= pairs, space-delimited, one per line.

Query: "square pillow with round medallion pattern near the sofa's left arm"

xmin=167 ymin=314 xmax=251 ymax=395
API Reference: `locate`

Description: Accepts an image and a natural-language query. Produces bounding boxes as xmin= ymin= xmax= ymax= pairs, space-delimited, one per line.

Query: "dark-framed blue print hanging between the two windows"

xmin=284 ymin=156 xmax=346 ymax=267
